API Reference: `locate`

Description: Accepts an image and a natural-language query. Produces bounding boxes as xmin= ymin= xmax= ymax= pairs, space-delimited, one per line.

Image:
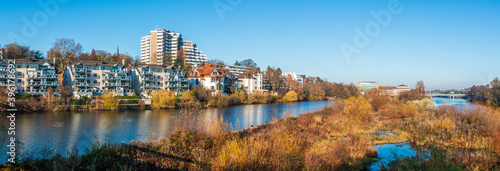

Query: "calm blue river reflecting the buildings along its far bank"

xmin=0 ymin=101 xmax=333 ymax=160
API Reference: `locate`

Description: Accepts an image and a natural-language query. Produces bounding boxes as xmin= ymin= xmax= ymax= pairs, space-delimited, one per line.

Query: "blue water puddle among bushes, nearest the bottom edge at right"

xmin=367 ymin=143 xmax=416 ymax=170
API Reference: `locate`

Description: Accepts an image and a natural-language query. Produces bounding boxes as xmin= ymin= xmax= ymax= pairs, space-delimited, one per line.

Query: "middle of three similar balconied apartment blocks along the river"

xmin=63 ymin=61 xmax=134 ymax=97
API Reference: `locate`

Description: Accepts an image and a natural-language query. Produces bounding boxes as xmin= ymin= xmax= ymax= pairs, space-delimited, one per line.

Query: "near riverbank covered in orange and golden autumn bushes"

xmin=2 ymin=96 xmax=500 ymax=170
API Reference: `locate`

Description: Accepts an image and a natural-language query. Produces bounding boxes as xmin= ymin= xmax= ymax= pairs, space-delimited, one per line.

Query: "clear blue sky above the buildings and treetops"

xmin=0 ymin=0 xmax=500 ymax=89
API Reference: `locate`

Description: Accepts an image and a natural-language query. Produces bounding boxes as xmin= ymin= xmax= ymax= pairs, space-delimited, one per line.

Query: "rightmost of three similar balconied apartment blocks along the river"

xmin=134 ymin=64 xmax=189 ymax=94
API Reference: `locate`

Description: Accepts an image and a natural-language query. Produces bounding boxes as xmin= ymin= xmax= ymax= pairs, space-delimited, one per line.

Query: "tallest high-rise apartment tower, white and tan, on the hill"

xmin=141 ymin=29 xmax=182 ymax=65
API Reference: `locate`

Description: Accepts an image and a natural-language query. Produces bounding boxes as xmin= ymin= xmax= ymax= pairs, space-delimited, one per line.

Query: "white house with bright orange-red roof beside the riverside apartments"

xmin=190 ymin=64 xmax=231 ymax=94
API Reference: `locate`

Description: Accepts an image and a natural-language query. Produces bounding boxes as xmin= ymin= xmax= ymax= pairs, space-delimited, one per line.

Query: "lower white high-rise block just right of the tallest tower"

xmin=180 ymin=41 xmax=207 ymax=68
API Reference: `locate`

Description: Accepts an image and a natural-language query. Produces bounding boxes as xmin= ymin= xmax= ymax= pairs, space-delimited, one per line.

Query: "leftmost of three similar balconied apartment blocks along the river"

xmin=0 ymin=59 xmax=59 ymax=95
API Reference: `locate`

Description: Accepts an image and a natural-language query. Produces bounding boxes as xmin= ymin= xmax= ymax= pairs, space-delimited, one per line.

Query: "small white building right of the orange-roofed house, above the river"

xmin=236 ymin=72 xmax=268 ymax=94
